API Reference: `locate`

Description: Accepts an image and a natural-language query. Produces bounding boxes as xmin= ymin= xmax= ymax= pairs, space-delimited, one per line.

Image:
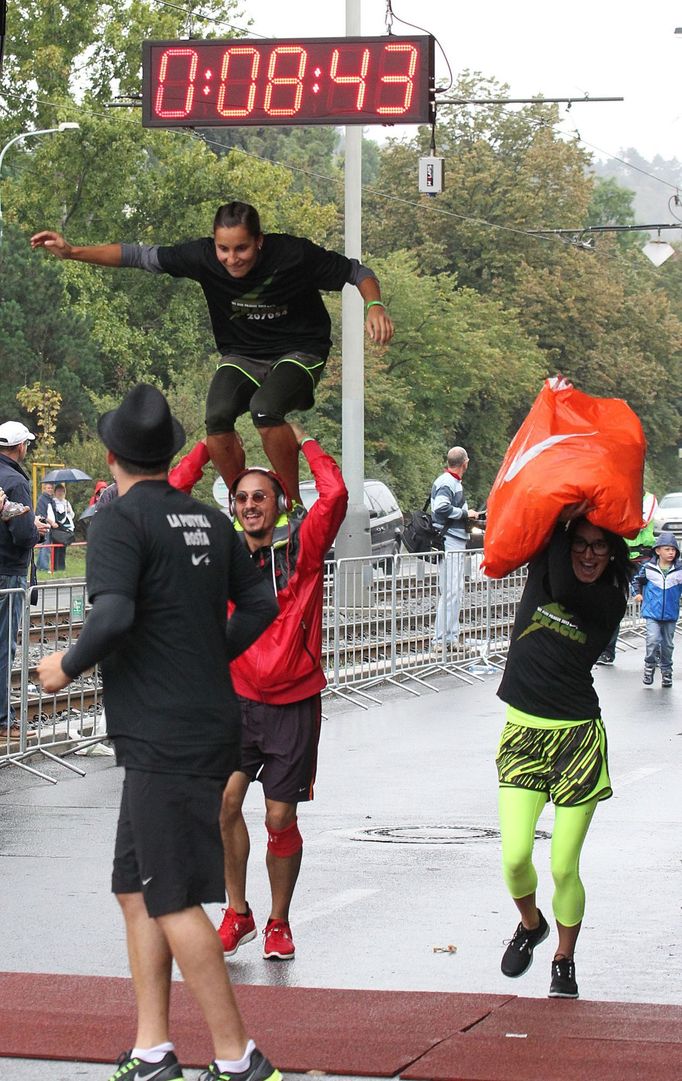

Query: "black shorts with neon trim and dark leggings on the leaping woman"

xmin=206 ymin=352 xmax=326 ymax=436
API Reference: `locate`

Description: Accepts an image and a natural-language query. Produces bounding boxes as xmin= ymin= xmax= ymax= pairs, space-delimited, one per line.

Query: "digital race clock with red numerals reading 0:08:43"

xmin=143 ymin=36 xmax=433 ymax=128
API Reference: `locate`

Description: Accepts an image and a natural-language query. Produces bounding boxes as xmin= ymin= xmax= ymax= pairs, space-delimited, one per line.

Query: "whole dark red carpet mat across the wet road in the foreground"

xmin=5 ymin=973 xmax=682 ymax=1081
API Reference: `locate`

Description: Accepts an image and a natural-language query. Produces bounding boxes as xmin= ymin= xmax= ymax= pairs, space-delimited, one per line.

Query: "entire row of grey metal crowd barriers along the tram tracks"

xmin=0 ymin=551 xmax=643 ymax=780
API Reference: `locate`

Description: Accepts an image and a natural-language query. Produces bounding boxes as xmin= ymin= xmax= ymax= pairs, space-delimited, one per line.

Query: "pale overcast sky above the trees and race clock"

xmin=234 ymin=0 xmax=682 ymax=160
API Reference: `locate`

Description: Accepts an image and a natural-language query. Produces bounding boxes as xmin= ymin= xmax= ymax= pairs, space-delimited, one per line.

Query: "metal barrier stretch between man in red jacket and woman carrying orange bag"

xmin=323 ymin=551 xmax=525 ymax=708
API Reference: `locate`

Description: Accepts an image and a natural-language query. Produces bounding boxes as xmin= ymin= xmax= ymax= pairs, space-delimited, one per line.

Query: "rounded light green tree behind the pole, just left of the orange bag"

xmin=306 ymin=252 xmax=545 ymax=506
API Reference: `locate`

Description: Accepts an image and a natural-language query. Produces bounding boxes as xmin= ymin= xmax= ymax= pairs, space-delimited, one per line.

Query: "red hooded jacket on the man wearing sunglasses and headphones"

xmin=169 ymin=439 xmax=348 ymax=706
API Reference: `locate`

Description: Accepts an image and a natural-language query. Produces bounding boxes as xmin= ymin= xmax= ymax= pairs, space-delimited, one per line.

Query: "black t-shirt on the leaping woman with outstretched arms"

xmin=158 ymin=233 xmax=352 ymax=360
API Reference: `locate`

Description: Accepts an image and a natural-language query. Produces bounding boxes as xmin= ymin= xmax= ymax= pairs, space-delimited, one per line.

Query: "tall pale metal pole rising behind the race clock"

xmin=336 ymin=0 xmax=371 ymax=557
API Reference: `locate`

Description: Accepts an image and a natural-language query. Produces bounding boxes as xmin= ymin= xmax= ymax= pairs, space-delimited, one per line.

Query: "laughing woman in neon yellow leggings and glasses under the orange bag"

xmin=497 ymin=505 xmax=629 ymax=998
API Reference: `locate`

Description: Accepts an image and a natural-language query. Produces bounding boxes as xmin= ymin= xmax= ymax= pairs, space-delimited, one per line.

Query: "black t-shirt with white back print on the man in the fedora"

xmin=86 ymin=481 xmax=269 ymax=779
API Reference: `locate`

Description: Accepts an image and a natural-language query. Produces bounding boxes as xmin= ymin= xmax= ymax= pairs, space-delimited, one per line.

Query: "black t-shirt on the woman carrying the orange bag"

xmin=497 ymin=528 xmax=627 ymax=721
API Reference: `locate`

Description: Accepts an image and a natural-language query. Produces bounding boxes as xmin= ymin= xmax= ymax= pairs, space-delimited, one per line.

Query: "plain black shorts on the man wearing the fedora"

xmin=111 ymin=770 xmax=225 ymax=917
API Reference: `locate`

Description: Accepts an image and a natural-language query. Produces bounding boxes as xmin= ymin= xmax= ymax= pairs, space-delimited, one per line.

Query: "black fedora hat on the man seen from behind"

xmin=97 ymin=383 xmax=185 ymax=466
